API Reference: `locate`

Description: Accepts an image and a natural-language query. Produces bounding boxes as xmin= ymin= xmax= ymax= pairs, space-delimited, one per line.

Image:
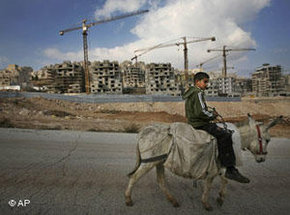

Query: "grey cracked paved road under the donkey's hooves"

xmin=0 ymin=129 xmax=290 ymax=215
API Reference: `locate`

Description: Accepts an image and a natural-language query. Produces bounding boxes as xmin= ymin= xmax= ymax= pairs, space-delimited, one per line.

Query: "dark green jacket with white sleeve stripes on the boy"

xmin=182 ymin=86 xmax=215 ymax=128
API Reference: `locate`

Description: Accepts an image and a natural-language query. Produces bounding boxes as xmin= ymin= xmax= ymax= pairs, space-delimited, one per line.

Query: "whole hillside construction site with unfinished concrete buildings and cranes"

xmin=0 ymin=10 xmax=290 ymax=97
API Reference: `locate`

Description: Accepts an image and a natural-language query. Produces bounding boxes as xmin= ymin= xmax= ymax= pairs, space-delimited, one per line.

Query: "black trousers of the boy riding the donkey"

xmin=196 ymin=123 xmax=236 ymax=167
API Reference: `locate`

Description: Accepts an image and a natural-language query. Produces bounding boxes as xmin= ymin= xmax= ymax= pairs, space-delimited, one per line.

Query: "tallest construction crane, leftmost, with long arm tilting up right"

xmin=59 ymin=10 xmax=149 ymax=94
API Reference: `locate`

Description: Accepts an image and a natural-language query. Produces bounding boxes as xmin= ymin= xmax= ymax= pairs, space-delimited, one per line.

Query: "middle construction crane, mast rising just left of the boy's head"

xmin=131 ymin=37 xmax=215 ymax=83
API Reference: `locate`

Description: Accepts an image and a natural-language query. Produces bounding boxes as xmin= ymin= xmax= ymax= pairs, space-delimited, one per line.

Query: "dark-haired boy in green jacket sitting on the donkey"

xmin=183 ymin=72 xmax=250 ymax=183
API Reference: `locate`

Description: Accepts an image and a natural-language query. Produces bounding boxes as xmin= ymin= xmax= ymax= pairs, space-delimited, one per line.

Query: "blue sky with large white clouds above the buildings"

xmin=0 ymin=0 xmax=290 ymax=76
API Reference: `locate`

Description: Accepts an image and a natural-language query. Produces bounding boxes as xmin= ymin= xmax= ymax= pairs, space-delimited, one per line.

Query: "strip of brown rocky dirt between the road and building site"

xmin=0 ymin=97 xmax=290 ymax=138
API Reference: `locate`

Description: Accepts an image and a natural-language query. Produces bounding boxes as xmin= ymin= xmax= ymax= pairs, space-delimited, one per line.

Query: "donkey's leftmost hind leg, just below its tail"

xmin=125 ymin=162 xmax=158 ymax=206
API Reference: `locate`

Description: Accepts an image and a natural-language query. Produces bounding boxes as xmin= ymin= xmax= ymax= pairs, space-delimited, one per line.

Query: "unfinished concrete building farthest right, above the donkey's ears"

xmin=252 ymin=64 xmax=284 ymax=96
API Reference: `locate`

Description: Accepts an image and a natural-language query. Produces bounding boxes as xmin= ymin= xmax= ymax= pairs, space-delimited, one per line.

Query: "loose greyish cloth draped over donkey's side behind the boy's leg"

xmin=164 ymin=123 xmax=218 ymax=179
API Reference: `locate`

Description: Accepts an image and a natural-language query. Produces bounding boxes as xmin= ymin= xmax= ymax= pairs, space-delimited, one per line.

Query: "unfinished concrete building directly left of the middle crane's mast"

xmin=145 ymin=63 xmax=181 ymax=96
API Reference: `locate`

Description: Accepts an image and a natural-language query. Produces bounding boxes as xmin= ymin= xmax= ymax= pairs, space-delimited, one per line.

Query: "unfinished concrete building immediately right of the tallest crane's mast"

xmin=89 ymin=60 xmax=123 ymax=94
